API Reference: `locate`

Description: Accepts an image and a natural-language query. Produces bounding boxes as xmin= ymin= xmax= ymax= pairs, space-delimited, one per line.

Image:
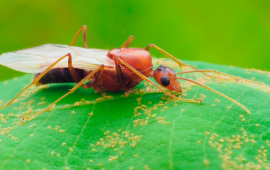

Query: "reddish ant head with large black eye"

xmin=153 ymin=65 xmax=182 ymax=93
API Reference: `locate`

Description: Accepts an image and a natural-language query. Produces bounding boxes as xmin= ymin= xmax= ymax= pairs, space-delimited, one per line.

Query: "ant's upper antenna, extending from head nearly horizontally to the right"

xmin=176 ymin=70 xmax=265 ymax=85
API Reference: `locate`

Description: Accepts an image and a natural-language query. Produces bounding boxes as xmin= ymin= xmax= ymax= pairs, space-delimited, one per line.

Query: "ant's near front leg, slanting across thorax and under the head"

xmin=116 ymin=58 xmax=202 ymax=103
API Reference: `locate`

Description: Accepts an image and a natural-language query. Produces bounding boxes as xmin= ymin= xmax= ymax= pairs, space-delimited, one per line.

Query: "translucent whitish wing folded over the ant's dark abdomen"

xmin=0 ymin=44 xmax=114 ymax=73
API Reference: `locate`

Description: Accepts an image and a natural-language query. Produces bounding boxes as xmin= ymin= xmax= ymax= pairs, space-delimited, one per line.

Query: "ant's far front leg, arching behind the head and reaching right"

xmin=146 ymin=44 xmax=264 ymax=85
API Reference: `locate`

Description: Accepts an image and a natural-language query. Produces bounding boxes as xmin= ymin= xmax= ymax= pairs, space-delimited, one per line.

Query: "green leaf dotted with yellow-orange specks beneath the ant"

xmin=0 ymin=60 xmax=270 ymax=169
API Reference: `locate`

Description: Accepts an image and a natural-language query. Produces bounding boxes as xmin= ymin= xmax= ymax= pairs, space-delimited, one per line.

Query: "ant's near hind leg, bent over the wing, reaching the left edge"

xmin=0 ymin=53 xmax=79 ymax=110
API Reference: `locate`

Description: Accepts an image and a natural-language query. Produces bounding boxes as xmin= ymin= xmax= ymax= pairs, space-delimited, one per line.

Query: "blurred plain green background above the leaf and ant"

xmin=0 ymin=0 xmax=270 ymax=80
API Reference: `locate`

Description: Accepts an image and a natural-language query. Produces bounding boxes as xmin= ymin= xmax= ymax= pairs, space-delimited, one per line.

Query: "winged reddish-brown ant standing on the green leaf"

xmin=0 ymin=26 xmax=253 ymax=120
